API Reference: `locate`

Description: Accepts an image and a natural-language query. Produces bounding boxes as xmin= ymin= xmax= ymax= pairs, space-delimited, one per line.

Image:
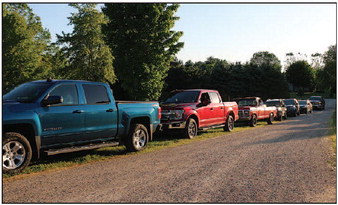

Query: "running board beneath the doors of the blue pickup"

xmin=45 ymin=142 xmax=120 ymax=156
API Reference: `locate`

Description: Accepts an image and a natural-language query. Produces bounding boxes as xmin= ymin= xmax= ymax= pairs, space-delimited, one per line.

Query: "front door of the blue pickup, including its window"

xmin=38 ymin=84 xmax=85 ymax=146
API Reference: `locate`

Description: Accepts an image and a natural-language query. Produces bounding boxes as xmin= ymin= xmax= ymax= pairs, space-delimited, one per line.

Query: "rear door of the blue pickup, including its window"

xmin=82 ymin=84 xmax=118 ymax=140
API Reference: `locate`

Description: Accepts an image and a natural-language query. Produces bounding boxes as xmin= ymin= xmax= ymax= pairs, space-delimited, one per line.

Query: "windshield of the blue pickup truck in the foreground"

xmin=3 ymin=82 xmax=51 ymax=102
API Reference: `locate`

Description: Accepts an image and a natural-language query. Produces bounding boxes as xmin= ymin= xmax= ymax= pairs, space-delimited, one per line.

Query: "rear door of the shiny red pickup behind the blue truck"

xmin=209 ymin=92 xmax=225 ymax=125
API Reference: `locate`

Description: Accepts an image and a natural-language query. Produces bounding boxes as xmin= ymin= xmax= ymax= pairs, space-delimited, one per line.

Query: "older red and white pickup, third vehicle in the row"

xmin=235 ymin=97 xmax=277 ymax=127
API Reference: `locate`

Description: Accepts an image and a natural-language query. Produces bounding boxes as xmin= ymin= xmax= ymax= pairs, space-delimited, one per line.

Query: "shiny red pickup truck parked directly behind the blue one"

xmin=160 ymin=89 xmax=238 ymax=139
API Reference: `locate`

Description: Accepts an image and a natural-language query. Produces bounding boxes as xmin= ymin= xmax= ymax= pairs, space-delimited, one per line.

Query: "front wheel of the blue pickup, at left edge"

xmin=2 ymin=132 xmax=32 ymax=174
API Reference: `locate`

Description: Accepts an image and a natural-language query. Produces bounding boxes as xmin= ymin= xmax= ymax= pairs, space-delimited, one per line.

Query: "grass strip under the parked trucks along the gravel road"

xmin=3 ymin=121 xmax=270 ymax=178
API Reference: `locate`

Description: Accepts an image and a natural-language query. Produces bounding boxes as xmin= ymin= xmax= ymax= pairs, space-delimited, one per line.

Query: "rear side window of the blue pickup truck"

xmin=82 ymin=84 xmax=110 ymax=104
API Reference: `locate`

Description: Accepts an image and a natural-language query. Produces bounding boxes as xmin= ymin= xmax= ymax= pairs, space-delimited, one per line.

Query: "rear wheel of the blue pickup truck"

xmin=125 ymin=124 xmax=149 ymax=152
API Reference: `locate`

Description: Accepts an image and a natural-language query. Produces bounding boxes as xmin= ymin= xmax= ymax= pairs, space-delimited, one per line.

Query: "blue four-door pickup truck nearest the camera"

xmin=2 ymin=79 xmax=161 ymax=173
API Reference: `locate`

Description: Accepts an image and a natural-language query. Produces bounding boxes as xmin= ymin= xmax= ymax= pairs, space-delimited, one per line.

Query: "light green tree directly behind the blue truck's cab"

xmin=57 ymin=4 xmax=116 ymax=84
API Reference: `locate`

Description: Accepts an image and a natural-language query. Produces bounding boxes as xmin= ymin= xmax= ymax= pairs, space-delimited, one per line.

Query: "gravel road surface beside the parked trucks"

xmin=2 ymin=100 xmax=336 ymax=203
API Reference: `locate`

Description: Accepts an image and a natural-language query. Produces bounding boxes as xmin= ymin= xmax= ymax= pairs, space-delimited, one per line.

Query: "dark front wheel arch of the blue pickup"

xmin=2 ymin=124 xmax=39 ymax=159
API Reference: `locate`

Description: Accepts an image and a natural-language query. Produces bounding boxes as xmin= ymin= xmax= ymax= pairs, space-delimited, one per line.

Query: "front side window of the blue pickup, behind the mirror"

xmin=49 ymin=85 xmax=79 ymax=105
